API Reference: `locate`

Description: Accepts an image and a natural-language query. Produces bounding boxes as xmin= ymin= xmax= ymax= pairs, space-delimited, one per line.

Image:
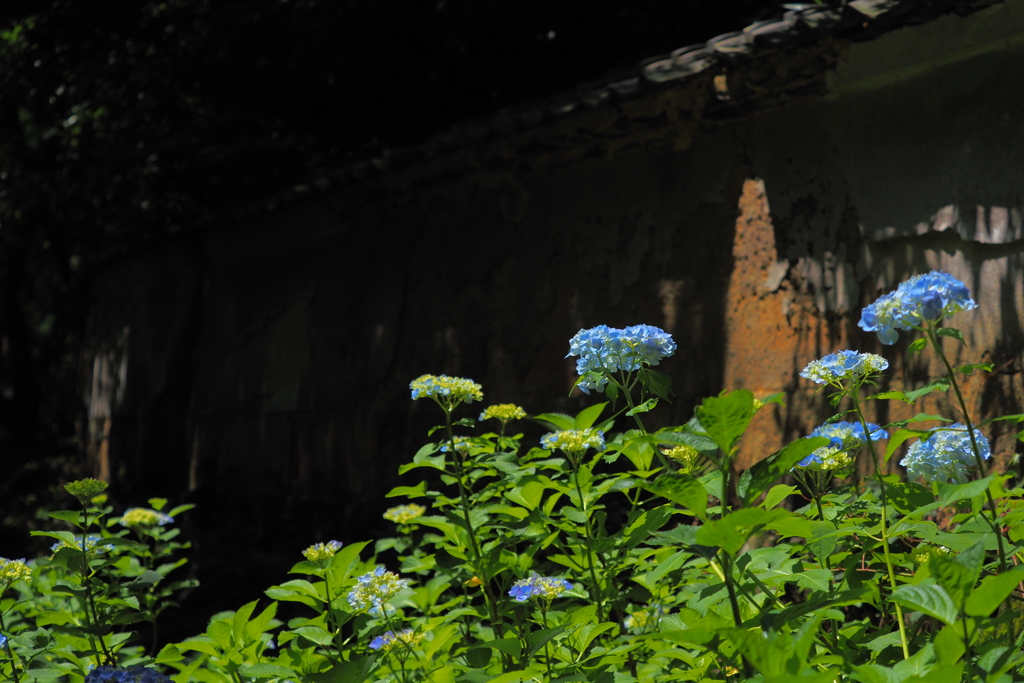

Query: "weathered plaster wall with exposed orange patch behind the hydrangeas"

xmin=83 ymin=0 xmax=1024 ymax=598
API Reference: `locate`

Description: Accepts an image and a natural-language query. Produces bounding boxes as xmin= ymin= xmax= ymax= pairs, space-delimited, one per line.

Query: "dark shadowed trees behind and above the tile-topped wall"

xmin=0 ymin=0 xmax=781 ymax=643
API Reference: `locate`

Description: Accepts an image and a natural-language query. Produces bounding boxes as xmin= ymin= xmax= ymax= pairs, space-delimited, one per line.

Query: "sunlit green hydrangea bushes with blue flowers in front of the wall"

xmin=0 ymin=272 xmax=1024 ymax=683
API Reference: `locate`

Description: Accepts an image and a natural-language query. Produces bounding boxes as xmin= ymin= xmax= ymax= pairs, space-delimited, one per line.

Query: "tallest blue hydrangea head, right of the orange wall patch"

xmin=857 ymin=270 xmax=978 ymax=345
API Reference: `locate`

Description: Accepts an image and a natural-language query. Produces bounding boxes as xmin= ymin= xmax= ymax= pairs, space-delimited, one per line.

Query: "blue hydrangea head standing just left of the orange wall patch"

xmin=565 ymin=325 xmax=677 ymax=393
